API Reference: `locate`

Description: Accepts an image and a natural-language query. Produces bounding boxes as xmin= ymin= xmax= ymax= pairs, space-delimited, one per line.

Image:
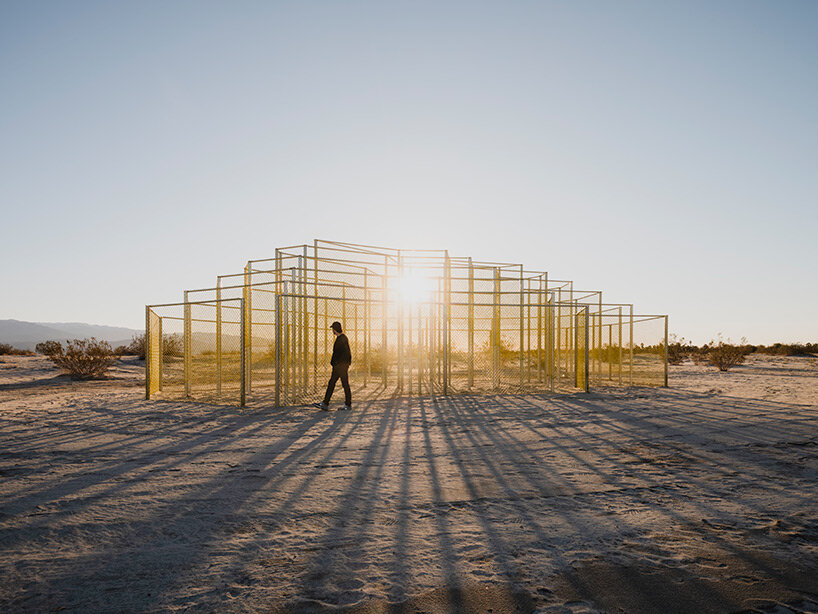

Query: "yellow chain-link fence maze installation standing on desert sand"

xmin=145 ymin=240 xmax=668 ymax=406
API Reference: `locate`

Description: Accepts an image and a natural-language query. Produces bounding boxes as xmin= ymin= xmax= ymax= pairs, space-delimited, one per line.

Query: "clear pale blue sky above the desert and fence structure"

xmin=0 ymin=0 xmax=818 ymax=343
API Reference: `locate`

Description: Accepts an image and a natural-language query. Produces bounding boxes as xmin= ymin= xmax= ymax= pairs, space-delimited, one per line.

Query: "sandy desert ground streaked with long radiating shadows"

xmin=0 ymin=357 xmax=818 ymax=614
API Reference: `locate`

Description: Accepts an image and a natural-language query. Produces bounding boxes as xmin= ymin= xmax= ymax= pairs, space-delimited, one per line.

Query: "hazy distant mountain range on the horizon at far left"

xmin=0 ymin=320 xmax=145 ymax=350
